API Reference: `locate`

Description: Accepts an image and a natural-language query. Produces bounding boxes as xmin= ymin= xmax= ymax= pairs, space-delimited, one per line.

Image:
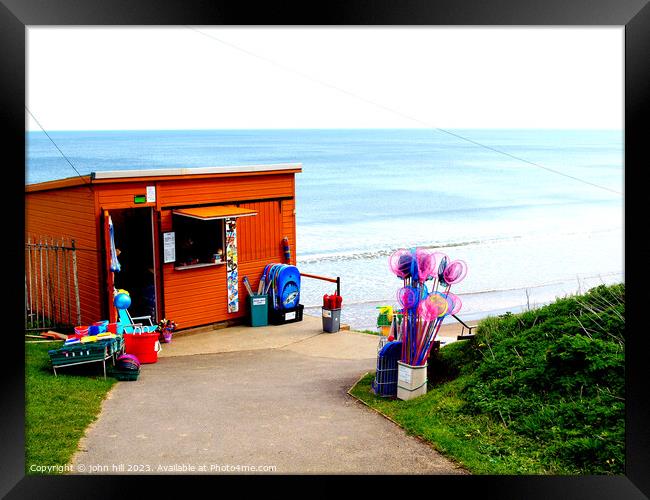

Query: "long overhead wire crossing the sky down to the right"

xmin=185 ymin=25 xmax=623 ymax=196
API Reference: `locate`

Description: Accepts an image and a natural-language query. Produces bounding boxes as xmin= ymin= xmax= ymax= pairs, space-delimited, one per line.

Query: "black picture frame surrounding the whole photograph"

xmin=0 ymin=0 xmax=650 ymax=499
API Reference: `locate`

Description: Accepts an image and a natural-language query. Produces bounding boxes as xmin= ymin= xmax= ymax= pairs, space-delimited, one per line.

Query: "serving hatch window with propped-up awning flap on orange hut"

xmin=172 ymin=205 xmax=257 ymax=267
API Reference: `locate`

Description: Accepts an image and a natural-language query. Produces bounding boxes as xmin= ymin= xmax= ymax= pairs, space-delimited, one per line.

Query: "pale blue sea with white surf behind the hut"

xmin=25 ymin=129 xmax=624 ymax=330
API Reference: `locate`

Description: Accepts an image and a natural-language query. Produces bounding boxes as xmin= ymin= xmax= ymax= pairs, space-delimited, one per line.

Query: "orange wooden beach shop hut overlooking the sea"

xmin=25 ymin=164 xmax=302 ymax=329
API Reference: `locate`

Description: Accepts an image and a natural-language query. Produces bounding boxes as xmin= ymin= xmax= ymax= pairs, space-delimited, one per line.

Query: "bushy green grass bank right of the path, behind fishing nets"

xmin=351 ymin=285 xmax=625 ymax=474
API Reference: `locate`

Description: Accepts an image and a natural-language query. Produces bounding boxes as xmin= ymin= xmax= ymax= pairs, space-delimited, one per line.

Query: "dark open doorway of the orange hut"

xmin=110 ymin=208 xmax=157 ymax=322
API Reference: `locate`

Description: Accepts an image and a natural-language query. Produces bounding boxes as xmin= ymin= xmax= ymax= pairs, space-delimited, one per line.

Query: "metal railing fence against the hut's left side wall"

xmin=25 ymin=236 xmax=81 ymax=331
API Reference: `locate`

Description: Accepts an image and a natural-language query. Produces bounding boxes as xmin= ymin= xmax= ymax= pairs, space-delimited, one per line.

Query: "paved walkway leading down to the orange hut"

xmin=73 ymin=317 xmax=463 ymax=474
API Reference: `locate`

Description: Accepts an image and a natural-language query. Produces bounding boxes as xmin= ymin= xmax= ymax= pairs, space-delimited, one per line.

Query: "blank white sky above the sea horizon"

xmin=27 ymin=27 xmax=624 ymax=130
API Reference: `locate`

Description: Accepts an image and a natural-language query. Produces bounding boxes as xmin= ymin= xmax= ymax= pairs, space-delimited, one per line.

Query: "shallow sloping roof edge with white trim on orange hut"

xmin=25 ymin=163 xmax=302 ymax=192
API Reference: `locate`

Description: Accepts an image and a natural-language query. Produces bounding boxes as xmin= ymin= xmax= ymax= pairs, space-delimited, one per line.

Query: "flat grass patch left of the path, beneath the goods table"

xmin=25 ymin=342 xmax=116 ymax=474
